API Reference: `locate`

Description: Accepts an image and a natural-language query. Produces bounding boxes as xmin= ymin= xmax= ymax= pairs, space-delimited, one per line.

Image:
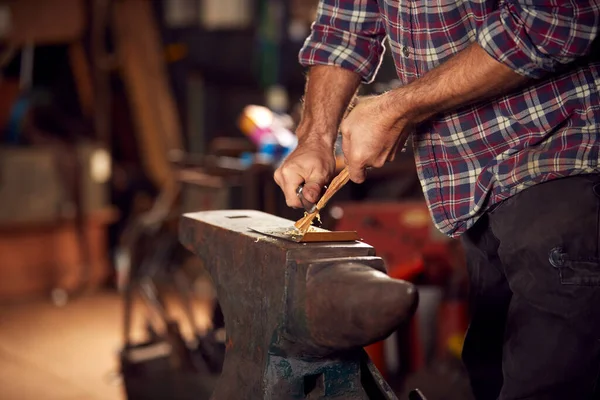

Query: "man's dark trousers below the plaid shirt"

xmin=462 ymin=175 xmax=600 ymax=400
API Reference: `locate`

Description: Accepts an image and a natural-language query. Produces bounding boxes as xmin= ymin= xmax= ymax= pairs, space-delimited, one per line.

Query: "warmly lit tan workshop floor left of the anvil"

xmin=0 ymin=292 xmax=209 ymax=400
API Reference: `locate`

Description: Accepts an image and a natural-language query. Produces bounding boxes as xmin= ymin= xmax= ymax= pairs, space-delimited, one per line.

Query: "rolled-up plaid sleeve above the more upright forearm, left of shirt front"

xmin=299 ymin=0 xmax=385 ymax=83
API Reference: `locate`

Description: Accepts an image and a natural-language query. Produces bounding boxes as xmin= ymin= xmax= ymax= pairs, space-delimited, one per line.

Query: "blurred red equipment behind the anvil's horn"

xmin=330 ymin=202 xmax=464 ymax=377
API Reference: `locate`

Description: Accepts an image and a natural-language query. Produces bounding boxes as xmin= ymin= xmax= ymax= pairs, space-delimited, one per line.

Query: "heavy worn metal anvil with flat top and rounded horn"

xmin=180 ymin=210 xmax=417 ymax=400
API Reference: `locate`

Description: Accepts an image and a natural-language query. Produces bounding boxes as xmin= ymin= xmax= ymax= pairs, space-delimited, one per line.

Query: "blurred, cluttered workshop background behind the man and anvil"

xmin=0 ymin=0 xmax=470 ymax=400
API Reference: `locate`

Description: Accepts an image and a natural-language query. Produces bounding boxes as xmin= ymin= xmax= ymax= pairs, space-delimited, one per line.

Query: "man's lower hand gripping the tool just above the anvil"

xmin=274 ymin=136 xmax=335 ymax=208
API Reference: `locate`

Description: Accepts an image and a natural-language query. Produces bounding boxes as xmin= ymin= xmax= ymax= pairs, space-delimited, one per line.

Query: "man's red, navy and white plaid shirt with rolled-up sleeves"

xmin=299 ymin=0 xmax=600 ymax=236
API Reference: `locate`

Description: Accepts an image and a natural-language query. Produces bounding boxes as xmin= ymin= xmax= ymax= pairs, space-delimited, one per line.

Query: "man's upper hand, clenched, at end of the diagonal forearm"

xmin=340 ymin=92 xmax=414 ymax=183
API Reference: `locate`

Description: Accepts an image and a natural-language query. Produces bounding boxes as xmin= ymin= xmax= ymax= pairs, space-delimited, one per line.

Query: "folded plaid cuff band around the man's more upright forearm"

xmin=298 ymin=24 xmax=385 ymax=83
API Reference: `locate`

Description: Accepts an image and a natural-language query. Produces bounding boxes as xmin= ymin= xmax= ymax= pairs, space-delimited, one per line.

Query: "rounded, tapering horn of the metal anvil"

xmin=306 ymin=262 xmax=418 ymax=350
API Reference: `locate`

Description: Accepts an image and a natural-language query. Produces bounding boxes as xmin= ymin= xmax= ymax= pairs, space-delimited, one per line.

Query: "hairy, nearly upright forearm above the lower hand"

xmin=296 ymin=65 xmax=360 ymax=145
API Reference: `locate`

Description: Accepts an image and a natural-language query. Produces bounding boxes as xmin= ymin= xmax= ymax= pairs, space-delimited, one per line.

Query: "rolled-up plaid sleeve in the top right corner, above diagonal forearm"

xmin=477 ymin=0 xmax=600 ymax=78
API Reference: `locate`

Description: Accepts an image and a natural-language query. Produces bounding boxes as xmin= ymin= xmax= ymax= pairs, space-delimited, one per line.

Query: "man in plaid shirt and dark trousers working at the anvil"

xmin=275 ymin=0 xmax=600 ymax=400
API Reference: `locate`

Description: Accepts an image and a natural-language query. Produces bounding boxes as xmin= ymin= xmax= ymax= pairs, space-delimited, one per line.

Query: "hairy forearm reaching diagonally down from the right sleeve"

xmin=390 ymin=43 xmax=530 ymax=122
